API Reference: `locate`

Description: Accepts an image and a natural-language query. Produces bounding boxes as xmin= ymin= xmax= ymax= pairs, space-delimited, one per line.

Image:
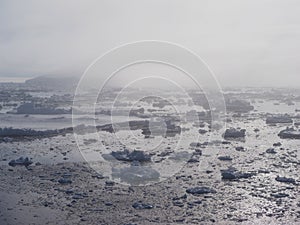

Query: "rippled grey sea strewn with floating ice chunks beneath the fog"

xmin=0 ymin=85 xmax=300 ymax=225
